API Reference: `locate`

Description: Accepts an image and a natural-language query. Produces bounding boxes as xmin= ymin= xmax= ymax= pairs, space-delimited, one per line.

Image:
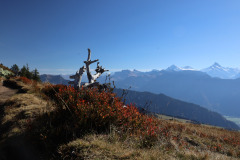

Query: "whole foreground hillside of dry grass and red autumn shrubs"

xmin=0 ymin=78 xmax=240 ymax=159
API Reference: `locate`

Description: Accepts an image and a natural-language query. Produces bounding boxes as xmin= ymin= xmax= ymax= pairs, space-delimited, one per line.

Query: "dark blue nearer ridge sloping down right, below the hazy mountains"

xmin=114 ymin=89 xmax=239 ymax=129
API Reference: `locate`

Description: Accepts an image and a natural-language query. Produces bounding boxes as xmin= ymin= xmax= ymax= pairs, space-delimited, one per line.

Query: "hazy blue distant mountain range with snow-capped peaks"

xmin=41 ymin=63 xmax=240 ymax=117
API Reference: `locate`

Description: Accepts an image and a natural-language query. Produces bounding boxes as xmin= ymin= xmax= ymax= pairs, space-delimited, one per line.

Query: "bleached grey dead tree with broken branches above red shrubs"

xmin=69 ymin=48 xmax=108 ymax=89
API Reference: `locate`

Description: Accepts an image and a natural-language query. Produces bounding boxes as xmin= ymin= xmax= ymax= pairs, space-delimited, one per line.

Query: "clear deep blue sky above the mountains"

xmin=0 ymin=0 xmax=240 ymax=74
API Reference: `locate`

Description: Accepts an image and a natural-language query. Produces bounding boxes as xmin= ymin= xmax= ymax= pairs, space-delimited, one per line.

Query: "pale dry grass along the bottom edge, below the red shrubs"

xmin=58 ymin=134 xmax=237 ymax=160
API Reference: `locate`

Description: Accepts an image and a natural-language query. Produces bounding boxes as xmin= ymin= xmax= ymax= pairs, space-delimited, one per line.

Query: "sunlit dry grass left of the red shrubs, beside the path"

xmin=1 ymin=80 xmax=54 ymax=139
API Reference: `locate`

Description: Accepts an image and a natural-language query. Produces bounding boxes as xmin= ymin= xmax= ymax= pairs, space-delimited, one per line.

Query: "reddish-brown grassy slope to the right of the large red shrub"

xmin=157 ymin=121 xmax=240 ymax=158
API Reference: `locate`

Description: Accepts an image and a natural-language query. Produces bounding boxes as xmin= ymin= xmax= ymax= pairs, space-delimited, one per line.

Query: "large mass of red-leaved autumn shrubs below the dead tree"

xmin=46 ymin=85 xmax=159 ymax=138
